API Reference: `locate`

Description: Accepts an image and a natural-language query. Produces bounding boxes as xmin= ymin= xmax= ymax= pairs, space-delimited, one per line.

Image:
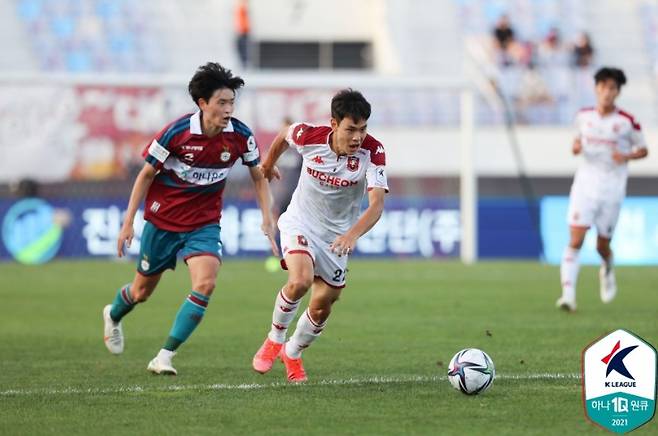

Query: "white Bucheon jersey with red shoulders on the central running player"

xmin=279 ymin=123 xmax=388 ymax=243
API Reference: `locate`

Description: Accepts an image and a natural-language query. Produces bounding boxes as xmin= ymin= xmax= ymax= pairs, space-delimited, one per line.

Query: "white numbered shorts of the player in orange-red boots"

xmin=279 ymin=220 xmax=348 ymax=288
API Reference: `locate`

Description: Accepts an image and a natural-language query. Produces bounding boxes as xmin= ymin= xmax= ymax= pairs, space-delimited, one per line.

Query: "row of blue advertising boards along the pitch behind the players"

xmin=0 ymin=196 xmax=658 ymax=265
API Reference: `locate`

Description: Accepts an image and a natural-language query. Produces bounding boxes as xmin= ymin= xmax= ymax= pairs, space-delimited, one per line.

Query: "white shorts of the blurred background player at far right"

xmin=567 ymin=186 xmax=624 ymax=239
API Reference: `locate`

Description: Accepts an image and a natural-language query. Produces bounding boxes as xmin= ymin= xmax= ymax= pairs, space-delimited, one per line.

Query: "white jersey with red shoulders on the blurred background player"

xmin=574 ymin=108 xmax=646 ymax=196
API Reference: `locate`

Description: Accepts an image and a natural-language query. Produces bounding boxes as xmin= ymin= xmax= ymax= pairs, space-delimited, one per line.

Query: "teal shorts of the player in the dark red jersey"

xmin=137 ymin=221 xmax=222 ymax=276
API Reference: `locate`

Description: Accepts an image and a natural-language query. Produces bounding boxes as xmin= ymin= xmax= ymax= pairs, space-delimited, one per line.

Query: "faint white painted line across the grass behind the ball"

xmin=0 ymin=373 xmax=581 ymax=397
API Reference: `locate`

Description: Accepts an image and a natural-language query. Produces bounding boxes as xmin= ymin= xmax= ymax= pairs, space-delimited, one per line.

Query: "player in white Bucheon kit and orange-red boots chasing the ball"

xmin=252 ymin=89 xmax=388 ymax=382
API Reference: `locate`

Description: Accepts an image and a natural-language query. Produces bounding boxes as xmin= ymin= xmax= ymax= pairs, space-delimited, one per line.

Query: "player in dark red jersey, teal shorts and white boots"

xmin=103 ymin=63 xmax=278 ymax=375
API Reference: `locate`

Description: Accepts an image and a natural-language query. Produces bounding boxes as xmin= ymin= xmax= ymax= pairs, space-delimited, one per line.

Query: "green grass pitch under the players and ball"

xmin=0 ymin=259 xmax=658 ymax=435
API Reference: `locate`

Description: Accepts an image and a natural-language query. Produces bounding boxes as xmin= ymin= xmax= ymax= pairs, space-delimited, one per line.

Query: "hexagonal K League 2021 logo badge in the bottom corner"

xmin=582 ymin=329 xmax=657 ymax=433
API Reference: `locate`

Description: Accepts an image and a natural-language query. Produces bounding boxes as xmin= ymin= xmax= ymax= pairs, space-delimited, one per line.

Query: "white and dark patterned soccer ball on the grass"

xmin=448 ymin=348 xmax=496 ymax=395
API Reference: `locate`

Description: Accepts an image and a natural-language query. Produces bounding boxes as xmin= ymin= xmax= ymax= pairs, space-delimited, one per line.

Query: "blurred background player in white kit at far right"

xmin=557 ymin=67 xmax=647 ymax=312
